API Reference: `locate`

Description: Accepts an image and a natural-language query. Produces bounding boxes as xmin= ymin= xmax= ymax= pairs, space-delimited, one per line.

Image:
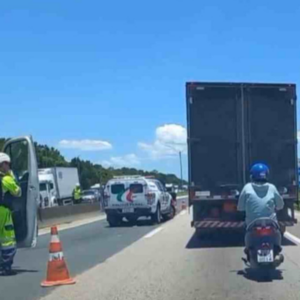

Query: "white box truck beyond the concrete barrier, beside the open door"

xmin=38 ymin=167 xmax=79 ymax=208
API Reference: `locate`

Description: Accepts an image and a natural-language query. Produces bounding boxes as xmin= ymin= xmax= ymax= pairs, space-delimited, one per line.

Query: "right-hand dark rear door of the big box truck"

xmin=244 ymin=85 xmax=298 ymax=198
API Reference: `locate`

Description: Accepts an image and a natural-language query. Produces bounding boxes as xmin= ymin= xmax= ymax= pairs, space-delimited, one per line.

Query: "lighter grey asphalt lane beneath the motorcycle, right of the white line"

xmin=41 ymin=209 xmax=300 ymax=300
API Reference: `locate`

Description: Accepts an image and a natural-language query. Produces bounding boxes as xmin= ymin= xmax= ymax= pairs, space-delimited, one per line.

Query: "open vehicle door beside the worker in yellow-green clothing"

xmin=3 ymin=136 xmax=39 ymax=247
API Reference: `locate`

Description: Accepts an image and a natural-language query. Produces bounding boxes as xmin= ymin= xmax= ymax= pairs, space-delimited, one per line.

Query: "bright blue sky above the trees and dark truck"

xmin=0 ymin=0 xmax=300 ymax=177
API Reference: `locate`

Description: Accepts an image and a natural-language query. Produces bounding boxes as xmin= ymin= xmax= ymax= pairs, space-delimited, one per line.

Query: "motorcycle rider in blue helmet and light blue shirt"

xmin=237 ymin=163 xmax=284 ymax=260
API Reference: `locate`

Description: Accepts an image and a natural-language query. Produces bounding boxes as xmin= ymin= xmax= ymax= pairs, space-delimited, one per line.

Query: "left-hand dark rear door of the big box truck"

xmin=187 ymin=83 xmax=243 ymax=196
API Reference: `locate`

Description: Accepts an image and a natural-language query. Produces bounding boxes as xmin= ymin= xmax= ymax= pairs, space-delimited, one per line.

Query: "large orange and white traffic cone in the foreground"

xmin=41 ymin=226 xmax=76 ymax=287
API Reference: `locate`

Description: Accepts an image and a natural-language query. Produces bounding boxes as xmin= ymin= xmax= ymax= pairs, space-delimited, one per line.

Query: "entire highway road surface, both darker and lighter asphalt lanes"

xmin=0 ymin=199 xmax=300 ymax=300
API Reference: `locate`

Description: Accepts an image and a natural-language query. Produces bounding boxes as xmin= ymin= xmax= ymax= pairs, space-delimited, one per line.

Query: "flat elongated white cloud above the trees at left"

xmin=58 ymin=140 xmax=112 ymax=151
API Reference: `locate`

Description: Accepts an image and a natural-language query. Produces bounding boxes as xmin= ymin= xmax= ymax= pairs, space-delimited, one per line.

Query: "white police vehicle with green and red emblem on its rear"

xmin=104 ymin=176 xmax=176 ymax=226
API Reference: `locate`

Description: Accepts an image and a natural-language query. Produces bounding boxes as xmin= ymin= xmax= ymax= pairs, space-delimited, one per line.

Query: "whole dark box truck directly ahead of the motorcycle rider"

xmin=186 ymin=82 xmax=298 ymax=236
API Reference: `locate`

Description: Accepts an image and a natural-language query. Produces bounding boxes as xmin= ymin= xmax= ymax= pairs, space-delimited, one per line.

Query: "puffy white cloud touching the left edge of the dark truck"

xmin=138 ymin=124 xmax=187 ymax=159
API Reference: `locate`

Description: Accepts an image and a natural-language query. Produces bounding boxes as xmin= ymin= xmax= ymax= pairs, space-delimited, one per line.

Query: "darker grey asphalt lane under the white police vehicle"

xmin=0 ymin=199 xmax=188 ymax=300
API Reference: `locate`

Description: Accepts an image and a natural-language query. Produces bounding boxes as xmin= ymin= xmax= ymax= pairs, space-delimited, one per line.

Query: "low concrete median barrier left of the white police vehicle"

xmin=38 ymin=202 xmax=103 ymax=228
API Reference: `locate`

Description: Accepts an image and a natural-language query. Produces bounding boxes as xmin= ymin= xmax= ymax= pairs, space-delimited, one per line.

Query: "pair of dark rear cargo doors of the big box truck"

xmin=187 ymin=83 xmax=298 ymax=198
